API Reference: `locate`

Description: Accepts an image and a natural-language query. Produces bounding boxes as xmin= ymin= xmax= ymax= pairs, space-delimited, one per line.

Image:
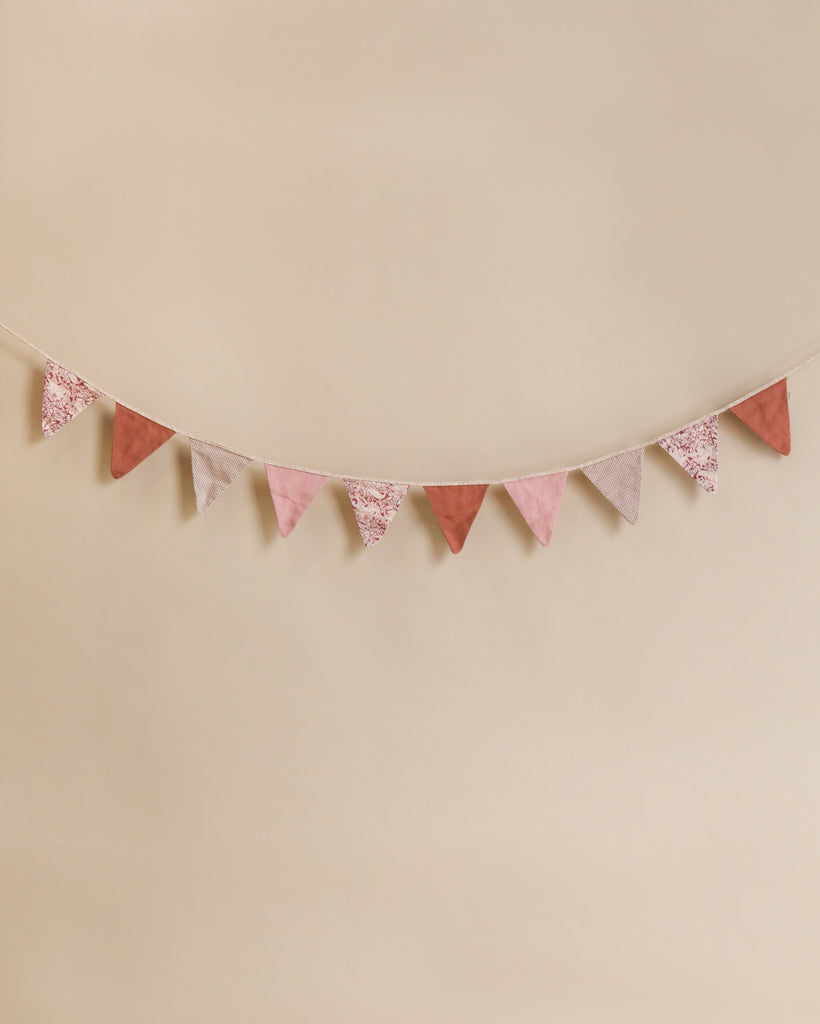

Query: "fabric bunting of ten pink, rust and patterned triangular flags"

xmin=38 ymin=350 xmax=798 ymax=554
